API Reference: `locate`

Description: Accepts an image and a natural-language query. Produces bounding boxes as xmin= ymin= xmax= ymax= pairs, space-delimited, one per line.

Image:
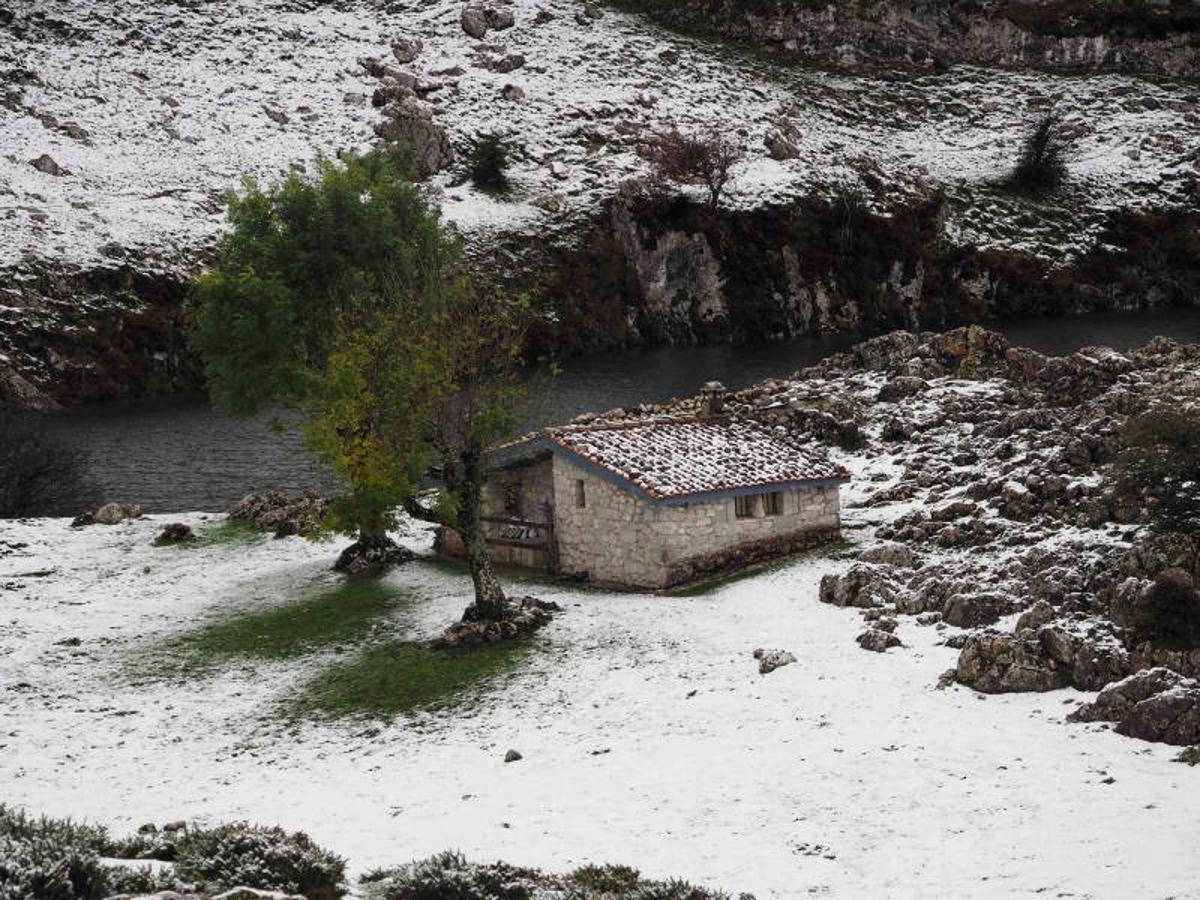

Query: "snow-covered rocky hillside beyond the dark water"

xmin=0 ymin=0 xmax=1200 ymax=274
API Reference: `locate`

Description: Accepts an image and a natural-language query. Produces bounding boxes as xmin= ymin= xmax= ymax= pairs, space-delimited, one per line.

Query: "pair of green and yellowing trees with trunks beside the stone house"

xmin=193 ymin=152 xmax=533 ymax=619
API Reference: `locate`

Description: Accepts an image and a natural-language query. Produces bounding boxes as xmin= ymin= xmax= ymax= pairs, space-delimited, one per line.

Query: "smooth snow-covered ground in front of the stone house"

xmin=0 ymin=504 xmax=1200 ymax=899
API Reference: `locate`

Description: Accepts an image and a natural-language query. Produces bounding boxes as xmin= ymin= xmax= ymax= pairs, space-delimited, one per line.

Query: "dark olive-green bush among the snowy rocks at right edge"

xmin=1117 ymin=409 xmax=1200 ymax=571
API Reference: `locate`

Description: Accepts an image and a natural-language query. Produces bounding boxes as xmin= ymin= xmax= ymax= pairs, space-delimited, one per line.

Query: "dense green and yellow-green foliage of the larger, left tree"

xmin=191 ymin=151 xmax=469 ymax=534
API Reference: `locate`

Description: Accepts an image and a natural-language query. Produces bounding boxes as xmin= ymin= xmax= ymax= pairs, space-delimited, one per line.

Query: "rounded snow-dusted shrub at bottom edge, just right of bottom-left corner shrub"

xmin=175 ymin=822 xmax=346 ymax=900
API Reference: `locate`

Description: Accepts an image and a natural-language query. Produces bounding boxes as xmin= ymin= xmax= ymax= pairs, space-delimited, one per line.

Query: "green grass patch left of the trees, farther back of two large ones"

xmin=160 ymin=578 xmax=412 ymax=667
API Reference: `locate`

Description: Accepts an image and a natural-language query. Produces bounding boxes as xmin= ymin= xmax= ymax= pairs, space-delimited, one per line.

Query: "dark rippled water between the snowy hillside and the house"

xmin=39 ymin=308 xmax=1200 ymax=512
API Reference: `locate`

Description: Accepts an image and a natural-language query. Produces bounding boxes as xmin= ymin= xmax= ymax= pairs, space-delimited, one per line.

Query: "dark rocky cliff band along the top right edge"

xmin=637 ymin=0 xmax=1200 ymax=77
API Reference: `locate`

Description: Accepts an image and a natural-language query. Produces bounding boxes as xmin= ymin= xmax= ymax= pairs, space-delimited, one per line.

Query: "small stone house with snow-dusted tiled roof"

xmin=443 ymin=388 xmax=848 ymax=589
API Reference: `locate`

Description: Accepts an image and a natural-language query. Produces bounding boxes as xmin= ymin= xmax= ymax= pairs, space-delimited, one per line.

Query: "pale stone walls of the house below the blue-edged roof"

xmin=553 ymin=456 xmax=840 ymax=588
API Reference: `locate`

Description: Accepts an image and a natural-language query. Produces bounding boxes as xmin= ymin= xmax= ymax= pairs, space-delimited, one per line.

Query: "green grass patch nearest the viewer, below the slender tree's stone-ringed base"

xmin=287 ymin=640 xmax=534 ymax=719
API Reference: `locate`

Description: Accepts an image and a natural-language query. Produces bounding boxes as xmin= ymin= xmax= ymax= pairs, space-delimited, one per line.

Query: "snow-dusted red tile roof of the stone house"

xmin=535 ymin=418 xmax=850 ymax=500
